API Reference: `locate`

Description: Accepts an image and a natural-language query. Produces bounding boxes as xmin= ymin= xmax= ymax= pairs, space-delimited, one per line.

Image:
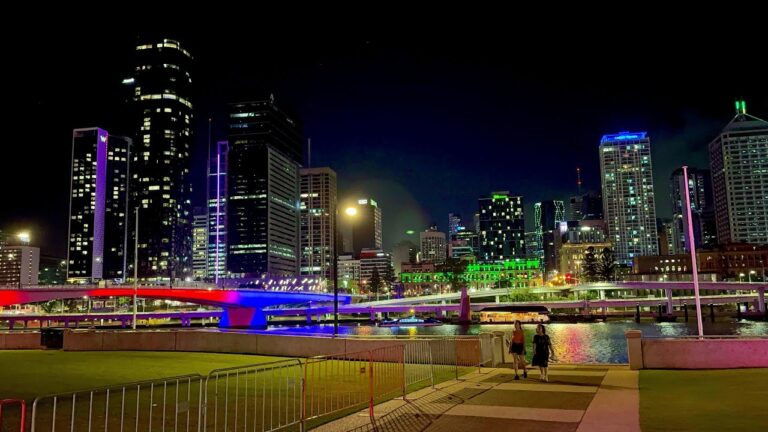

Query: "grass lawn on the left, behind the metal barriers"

xmin=0 ymin=351 xmax=283 ymax=400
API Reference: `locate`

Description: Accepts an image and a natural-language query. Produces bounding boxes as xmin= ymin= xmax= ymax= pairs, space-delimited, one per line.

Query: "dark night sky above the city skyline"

xmin=0 ymin=16 xmax=768 ymax=256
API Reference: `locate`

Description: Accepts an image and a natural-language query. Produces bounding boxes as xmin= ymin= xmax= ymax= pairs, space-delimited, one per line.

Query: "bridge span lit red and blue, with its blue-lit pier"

xmin=0 ymin=285 xmax=351 ymax=327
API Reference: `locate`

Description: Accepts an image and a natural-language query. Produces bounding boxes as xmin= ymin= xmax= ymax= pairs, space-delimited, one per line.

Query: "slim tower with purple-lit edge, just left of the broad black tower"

xmin=207 ymin=141 xmax=229 ymax=284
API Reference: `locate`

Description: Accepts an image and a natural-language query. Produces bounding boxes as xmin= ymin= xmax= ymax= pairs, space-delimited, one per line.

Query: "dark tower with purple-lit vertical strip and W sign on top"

xmin=67 ymin=128 xmax=132 ymax=283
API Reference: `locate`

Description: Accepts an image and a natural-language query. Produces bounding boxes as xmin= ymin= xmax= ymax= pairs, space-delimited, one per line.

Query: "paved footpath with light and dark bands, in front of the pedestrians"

xmin=315 ymin=365 xmax=640 ymax=432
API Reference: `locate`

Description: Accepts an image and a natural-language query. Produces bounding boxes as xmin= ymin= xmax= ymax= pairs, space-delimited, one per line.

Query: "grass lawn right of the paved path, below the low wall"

xmin=640 ymin=369 xmax=768 ymax=432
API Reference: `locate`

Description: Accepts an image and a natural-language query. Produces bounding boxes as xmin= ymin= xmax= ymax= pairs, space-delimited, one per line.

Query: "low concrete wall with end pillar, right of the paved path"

xmin=627 ymin=331 xmax=768 ymax=369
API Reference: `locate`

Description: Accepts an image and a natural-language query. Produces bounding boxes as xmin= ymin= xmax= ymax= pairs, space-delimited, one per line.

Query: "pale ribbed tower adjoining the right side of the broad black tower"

xmin=299 ymin=167 xmax=337 ymax=284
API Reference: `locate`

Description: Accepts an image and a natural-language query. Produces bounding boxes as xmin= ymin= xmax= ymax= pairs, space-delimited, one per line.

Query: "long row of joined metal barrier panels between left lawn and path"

xmin=25 ymin=335 xmax=494 ymax=432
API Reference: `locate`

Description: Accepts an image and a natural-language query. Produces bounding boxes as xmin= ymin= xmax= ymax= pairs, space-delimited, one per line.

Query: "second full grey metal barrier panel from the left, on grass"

xmin=203 ymin=359 xmax=303 ymax=432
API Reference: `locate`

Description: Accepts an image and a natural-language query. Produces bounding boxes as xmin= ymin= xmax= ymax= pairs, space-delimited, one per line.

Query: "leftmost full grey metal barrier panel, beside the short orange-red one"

xmin=31 ymin=374 xmax=203 ymax=432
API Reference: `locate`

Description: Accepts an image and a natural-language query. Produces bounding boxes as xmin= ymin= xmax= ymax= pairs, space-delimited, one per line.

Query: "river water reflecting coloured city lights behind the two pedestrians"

xmin=243 ymin=320 xmax=768 ymax=363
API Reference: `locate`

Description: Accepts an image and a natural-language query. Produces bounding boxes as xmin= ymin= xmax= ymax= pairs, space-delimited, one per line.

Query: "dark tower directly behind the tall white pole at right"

xmin=662 ymin=168 xmax=717 ymax=251
